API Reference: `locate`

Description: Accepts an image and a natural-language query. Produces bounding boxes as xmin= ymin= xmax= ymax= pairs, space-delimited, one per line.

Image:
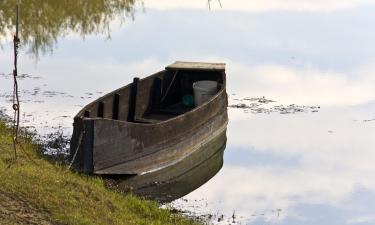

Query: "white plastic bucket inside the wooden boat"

xmin=193 ymin=80 xmax=217 ymax=106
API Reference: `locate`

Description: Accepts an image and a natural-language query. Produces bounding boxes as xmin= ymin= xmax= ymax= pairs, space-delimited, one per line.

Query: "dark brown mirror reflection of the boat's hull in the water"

xmin=105 ymin=127 xmax=227 ymax=203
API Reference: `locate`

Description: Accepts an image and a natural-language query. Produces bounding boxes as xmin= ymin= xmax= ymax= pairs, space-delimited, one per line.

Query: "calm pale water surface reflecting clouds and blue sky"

xmin=0 ymin=0 xmax=375 ymax=225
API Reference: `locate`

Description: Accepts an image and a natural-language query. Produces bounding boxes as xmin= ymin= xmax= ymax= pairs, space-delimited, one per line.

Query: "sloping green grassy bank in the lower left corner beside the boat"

xmin=0 ymin=122 xmax=200 ymax=225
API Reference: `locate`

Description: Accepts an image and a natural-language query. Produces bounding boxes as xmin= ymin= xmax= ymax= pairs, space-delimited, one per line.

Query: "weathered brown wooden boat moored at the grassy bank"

xmin=70 ymin=62 xmax=228 ymax=175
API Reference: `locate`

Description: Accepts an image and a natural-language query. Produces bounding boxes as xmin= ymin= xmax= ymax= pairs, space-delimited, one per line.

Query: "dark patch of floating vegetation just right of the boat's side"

xmin=228 ymin=96 xmax=320 ymax=114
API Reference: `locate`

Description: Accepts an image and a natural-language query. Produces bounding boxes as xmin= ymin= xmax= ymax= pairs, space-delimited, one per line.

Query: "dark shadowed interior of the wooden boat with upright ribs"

xmin=77 ymin=62 xmax=225 ymax=123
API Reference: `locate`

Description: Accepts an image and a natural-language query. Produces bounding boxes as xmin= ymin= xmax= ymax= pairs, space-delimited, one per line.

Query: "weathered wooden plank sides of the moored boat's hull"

xmin=71 ymin=62 xmax=228 ymax=175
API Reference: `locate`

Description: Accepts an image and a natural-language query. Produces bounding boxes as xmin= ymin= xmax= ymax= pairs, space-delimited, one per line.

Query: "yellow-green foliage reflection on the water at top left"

xmin=0 ymin=0 xmax=136 ymax=58
